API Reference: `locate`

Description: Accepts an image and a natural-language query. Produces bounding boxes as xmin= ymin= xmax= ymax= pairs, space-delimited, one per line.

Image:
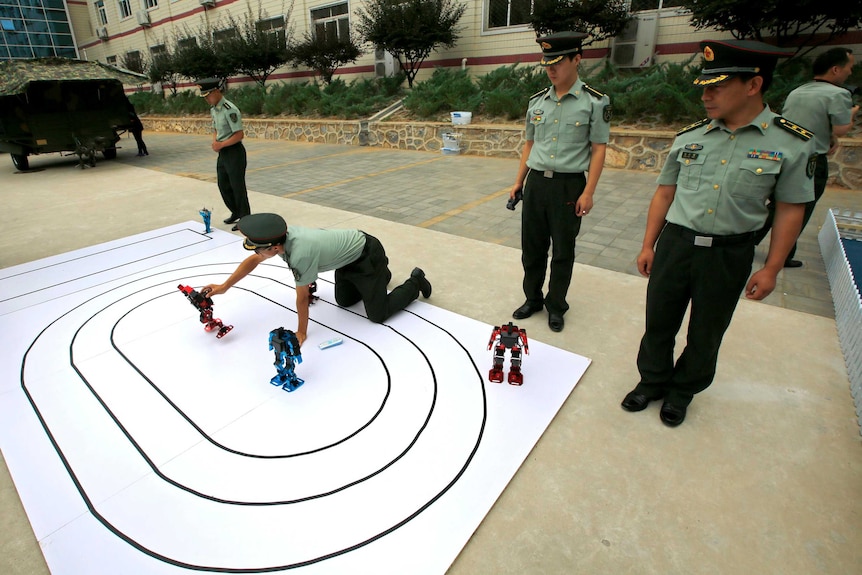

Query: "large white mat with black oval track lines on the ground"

xmin=0 ymin=222 xmax=589 ymax=575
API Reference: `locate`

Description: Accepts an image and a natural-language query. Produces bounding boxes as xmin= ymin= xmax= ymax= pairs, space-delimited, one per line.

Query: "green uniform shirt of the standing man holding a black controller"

xmin=526 ymin=78 xmax=611 ymax=173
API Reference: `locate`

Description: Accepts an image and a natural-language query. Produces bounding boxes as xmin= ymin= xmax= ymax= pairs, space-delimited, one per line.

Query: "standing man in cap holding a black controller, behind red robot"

xmin=509 ymin=32 xmax=611 ymax=331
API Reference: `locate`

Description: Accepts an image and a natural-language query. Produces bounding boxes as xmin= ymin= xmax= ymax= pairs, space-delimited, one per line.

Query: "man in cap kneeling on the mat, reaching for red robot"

xmin=201 ymin=214 xmax=431 ymax=345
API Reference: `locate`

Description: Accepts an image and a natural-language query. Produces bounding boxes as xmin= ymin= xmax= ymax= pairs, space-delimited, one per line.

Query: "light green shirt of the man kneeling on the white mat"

xmin=281 ymin=226 xmax=365 ymax=286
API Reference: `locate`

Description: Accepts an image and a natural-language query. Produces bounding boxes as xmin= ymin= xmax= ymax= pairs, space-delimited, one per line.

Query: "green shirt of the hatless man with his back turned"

xmin=781 ymin=80 xmax=853 ymax=154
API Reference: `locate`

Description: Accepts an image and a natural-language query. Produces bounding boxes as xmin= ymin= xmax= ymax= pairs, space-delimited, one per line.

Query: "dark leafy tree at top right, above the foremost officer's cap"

xmin=680 ymin=0 xmax=862 ymax=55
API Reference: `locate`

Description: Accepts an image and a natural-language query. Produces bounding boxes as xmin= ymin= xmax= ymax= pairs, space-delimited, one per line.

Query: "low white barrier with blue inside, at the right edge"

xmin=818 ymin=208 xmax=862 ymax=433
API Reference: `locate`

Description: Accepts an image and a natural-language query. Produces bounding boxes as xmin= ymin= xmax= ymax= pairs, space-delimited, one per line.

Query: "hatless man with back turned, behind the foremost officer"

xmin=757 ymin=48 xmax=859 ymax=268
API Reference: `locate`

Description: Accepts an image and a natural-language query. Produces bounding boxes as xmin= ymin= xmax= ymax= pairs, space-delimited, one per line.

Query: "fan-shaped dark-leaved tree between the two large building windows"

xmin=356 ymin=0 xmax=467 ymax=88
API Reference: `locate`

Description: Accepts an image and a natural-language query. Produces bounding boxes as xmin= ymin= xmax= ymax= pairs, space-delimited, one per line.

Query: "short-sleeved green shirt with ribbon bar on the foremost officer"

xmin=658 ymin=106 xmax=814 ymax=235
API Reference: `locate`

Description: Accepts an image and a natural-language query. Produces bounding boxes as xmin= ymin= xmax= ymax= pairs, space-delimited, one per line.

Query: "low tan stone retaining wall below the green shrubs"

xmin=147 ymin=116 xmax=862 ymax=190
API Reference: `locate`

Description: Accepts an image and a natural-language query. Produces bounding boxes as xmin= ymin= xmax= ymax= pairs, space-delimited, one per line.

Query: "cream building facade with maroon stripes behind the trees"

xmin=13 ymin=0 xmax=862 ymax=89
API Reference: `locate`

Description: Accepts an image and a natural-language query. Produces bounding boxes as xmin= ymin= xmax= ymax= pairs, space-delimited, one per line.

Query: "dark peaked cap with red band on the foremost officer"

xmin=694 ymin=40 xmax=793 ymax=86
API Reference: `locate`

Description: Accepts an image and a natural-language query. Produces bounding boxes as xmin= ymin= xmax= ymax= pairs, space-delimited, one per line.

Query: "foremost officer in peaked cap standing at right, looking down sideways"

xmin=622 ymin=40 xmax=815 ymax=427
